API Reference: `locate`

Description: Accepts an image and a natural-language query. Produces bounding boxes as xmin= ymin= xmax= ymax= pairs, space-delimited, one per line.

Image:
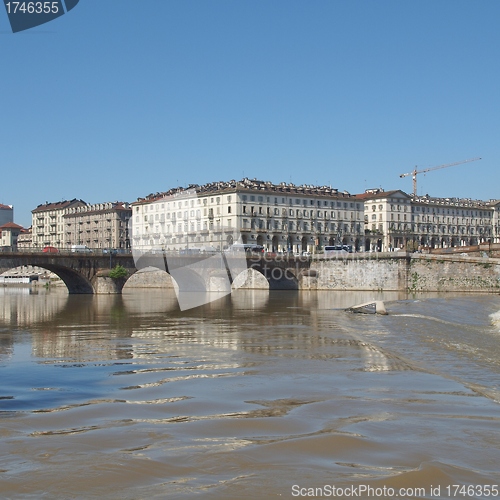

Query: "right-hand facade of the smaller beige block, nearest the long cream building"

xmin=62 ymin=202 xmax=132 ymax=249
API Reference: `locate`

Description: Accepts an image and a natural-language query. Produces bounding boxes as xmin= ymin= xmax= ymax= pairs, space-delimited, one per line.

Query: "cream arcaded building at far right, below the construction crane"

xmin=357 ymin=189 xmax=500 ymax=251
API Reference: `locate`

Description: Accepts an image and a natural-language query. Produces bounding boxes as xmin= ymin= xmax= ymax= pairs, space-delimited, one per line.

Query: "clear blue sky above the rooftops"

xmin=0 ymin=0 xmax=500 ymax=226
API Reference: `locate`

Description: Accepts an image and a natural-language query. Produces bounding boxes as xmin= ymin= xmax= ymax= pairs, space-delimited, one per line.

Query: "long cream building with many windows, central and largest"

xmin=132 ymin=179 xmax=364 ymax=253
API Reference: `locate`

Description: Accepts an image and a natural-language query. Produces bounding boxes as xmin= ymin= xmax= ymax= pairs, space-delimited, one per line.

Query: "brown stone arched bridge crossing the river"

xmin=0 ymin=251 xmax=311 ymax=294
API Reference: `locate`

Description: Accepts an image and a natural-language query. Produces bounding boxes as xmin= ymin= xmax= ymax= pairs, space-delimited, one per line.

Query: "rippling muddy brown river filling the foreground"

xmin=0 ymin=288 xmax=500 ymax=499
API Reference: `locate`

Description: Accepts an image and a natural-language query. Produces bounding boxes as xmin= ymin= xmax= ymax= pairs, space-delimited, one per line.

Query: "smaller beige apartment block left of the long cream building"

xmin=32 ymin=199 xmax=132 ymax=249
